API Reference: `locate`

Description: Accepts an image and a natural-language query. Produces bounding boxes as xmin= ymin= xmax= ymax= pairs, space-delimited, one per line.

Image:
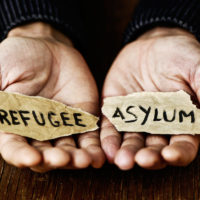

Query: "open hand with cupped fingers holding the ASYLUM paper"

xmin=101 ymin=28 xmax=200 ymax=170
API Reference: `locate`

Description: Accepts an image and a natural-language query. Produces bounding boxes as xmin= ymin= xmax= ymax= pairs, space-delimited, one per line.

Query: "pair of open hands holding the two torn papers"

xmin=0 ymin=22 xmax=200 ymax=172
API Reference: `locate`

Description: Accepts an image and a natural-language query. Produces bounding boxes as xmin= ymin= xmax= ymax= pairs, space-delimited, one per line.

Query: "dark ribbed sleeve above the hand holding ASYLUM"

xmin=124 ymin=0 xmax=200 ymax=44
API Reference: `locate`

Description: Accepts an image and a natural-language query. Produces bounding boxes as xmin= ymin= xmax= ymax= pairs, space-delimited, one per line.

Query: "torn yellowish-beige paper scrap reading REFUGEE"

xmin=0 ymin=91 xmax=98 ymax=141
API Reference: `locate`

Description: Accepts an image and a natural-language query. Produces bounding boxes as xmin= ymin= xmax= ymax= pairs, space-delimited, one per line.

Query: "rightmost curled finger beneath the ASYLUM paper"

xmin=162 ymin=135 xmax=199 ymax=166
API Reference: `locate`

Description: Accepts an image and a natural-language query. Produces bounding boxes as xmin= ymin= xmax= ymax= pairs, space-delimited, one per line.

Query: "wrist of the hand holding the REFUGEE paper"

xmin=7 ymin=22 xmax=73 ymax=46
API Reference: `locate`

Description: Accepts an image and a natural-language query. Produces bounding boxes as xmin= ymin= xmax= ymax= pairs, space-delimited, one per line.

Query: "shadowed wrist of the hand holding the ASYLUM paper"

xmin=138 ymin=27 xmax=195 ymax=40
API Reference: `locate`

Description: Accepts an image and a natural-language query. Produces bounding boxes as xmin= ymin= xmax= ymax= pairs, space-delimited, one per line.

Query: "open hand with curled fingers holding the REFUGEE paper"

xmin=0 ymin=22 xmax=105 ymax=172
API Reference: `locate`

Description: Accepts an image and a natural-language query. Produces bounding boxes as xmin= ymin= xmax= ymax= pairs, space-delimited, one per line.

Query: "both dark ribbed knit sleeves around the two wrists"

xmin=0 ymin=0 xmax=200 ymax=46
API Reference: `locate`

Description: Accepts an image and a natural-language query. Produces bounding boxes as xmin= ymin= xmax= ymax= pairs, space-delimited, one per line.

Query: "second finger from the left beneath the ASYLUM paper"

xmin=115 ymin=133 xmax=144 ymax=170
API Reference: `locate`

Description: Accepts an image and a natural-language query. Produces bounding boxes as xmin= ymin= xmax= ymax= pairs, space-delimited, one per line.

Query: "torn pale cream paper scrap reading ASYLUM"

xmin=102 ymin=91 xmax=200 ymax=134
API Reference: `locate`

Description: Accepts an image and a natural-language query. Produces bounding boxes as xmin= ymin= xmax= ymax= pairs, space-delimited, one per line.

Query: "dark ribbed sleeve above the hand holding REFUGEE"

xmin=0 ymin=0 xmax=83 ymax=46
